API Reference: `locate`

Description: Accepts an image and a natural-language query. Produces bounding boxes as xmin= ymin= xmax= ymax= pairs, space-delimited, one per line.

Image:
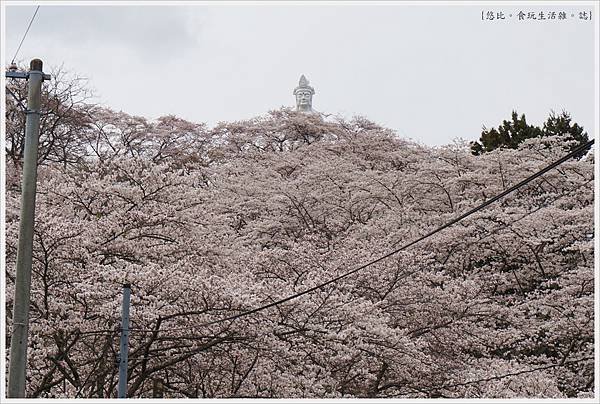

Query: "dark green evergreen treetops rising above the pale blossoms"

xmin=471 ymin=111 xmax=588 ymax=155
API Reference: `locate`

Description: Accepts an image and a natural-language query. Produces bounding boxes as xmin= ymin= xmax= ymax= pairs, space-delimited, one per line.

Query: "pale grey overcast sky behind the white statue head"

xmin=3 ymin=2 xmax=598 ymax=145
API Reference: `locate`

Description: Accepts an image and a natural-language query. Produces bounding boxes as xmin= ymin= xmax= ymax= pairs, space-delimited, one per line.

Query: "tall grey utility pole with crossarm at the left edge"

xmin=6 ymin=59 xmax=50 ymax=398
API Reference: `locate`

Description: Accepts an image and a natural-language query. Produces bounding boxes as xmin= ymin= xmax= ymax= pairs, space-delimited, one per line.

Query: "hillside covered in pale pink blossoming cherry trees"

xmin=5 ymin=72 xmax=594 ymax=398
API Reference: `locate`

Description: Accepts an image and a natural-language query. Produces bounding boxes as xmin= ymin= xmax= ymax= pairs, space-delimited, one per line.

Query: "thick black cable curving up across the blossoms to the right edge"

xmin=127 ymin=139 xmax=594 ymax=332
